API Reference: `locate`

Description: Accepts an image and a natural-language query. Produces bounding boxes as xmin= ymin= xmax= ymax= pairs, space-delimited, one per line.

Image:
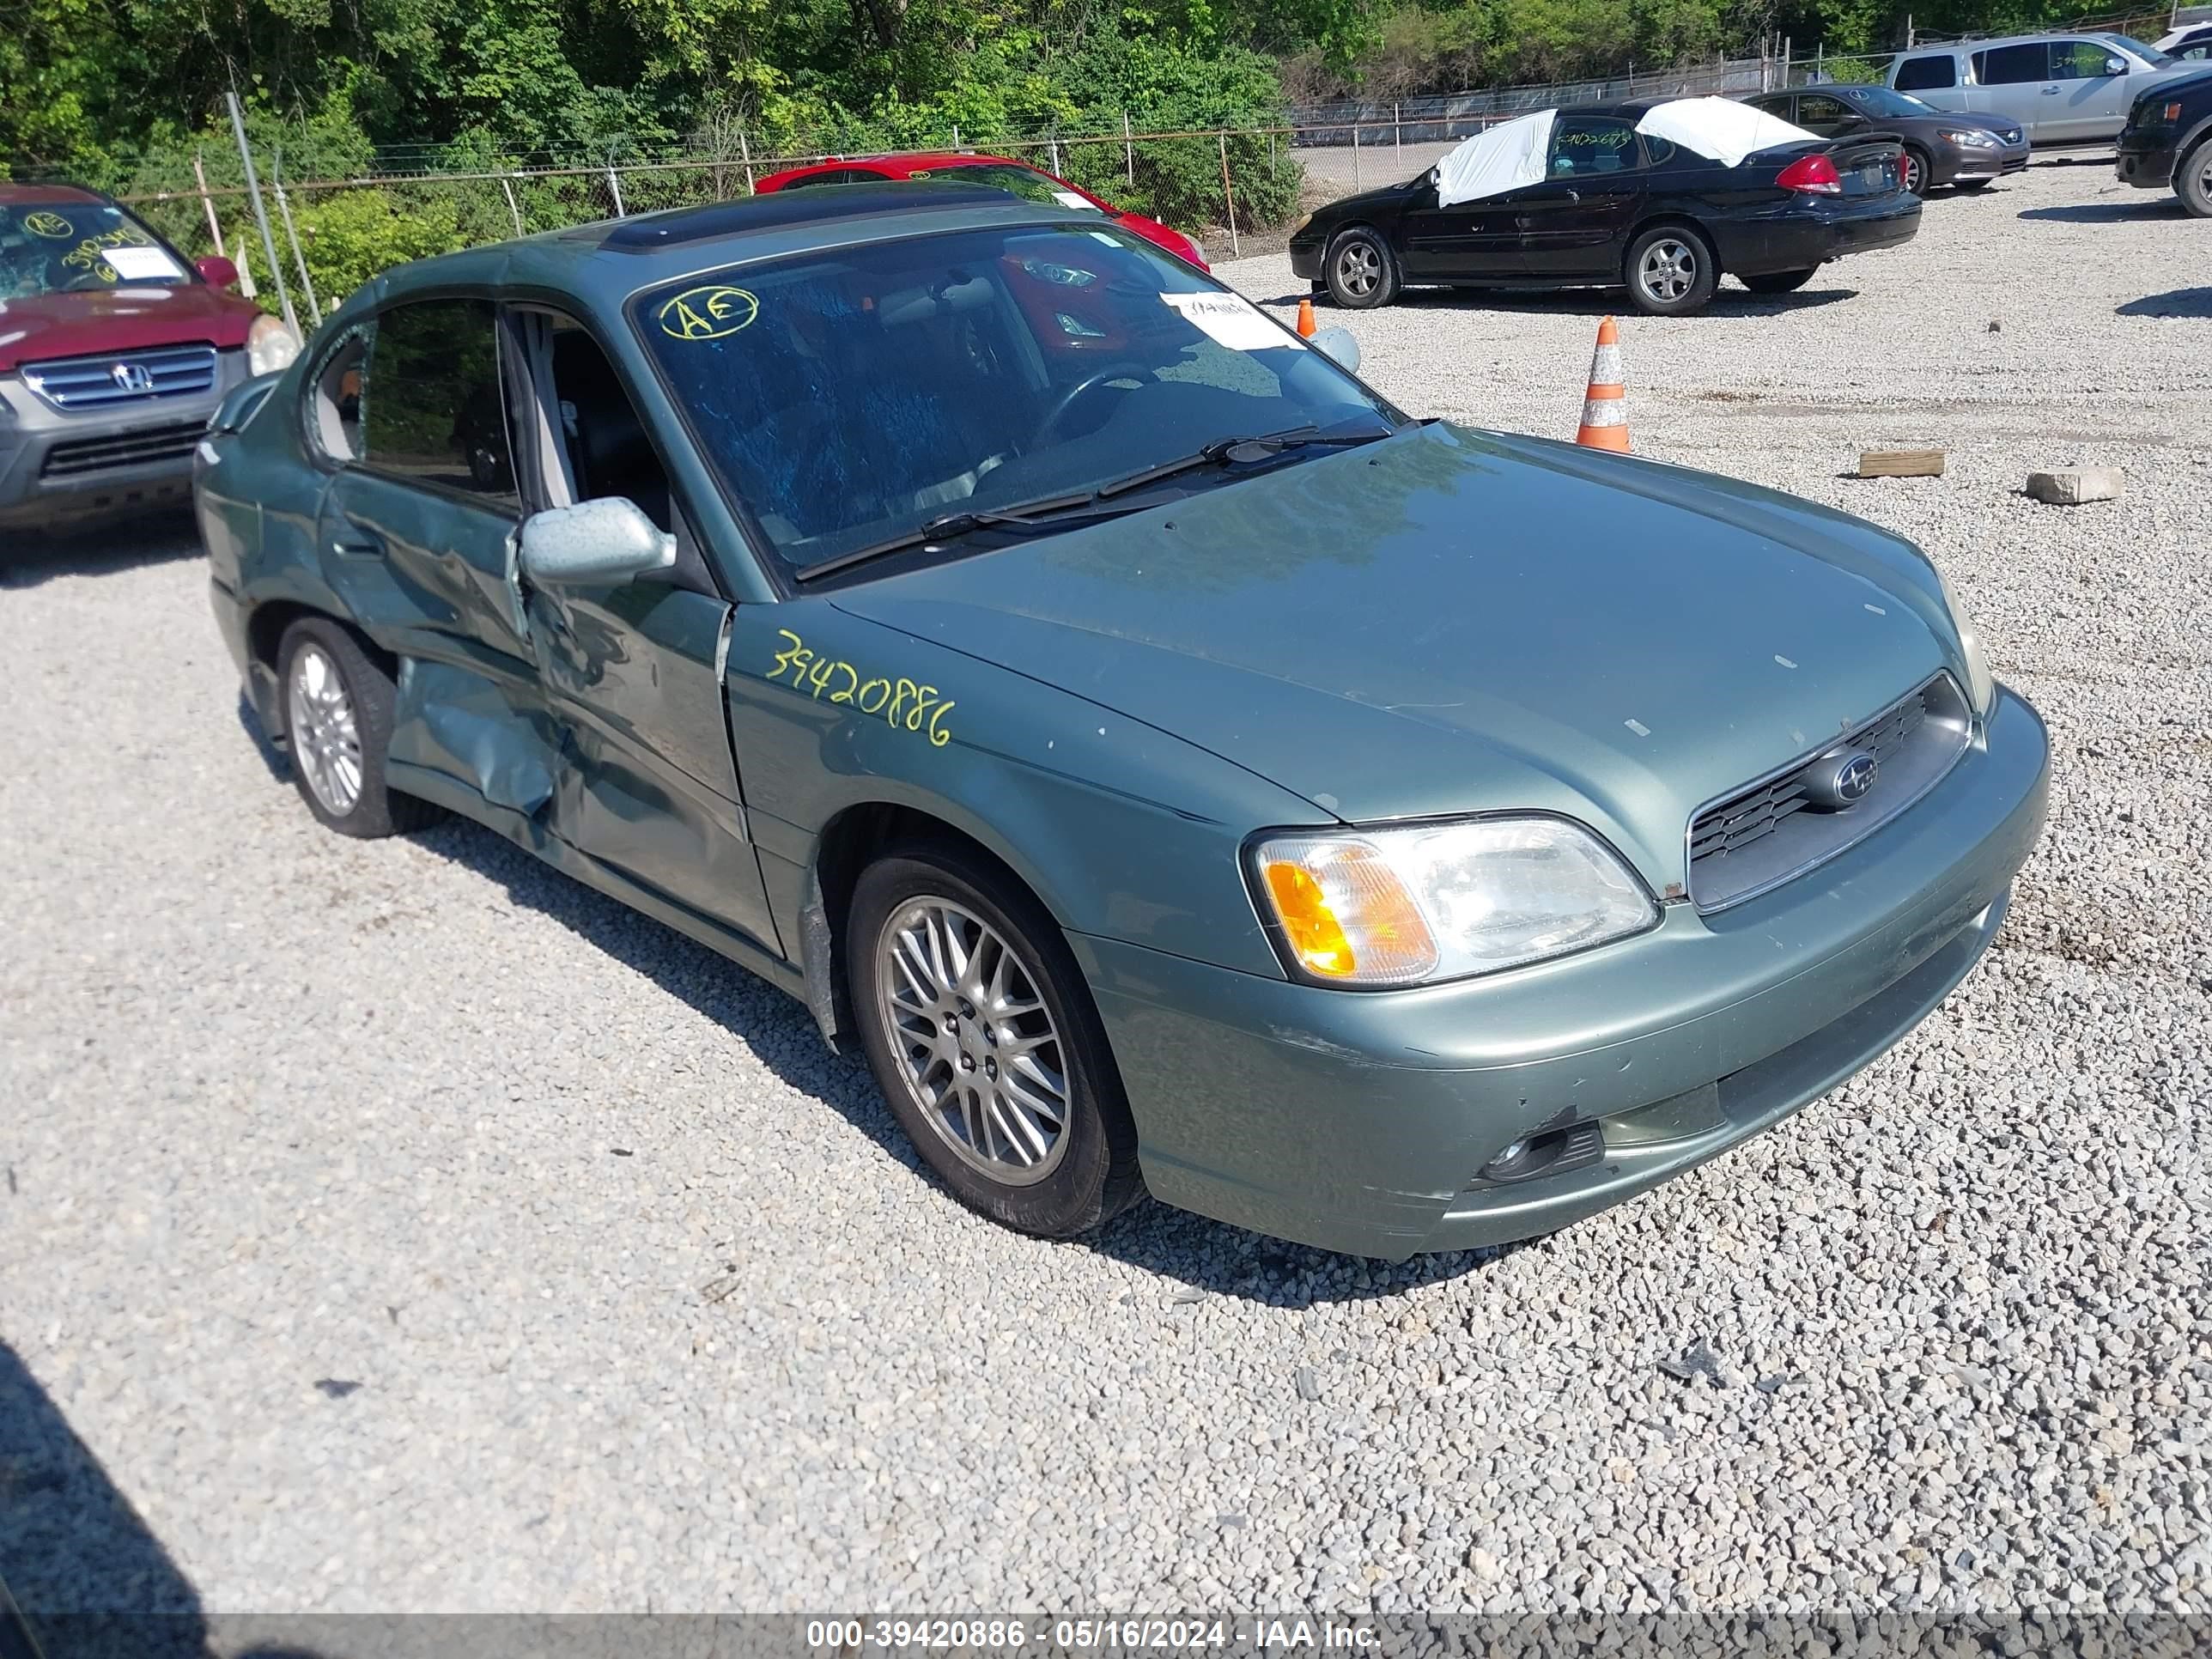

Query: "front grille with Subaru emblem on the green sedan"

xmin=1690 ymin=675 xmax=1973 ymax=909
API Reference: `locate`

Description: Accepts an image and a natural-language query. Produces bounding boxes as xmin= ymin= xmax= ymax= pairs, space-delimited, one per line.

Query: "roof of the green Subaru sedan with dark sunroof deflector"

xmin=327 ymin=179 xmax=1097 ymax=312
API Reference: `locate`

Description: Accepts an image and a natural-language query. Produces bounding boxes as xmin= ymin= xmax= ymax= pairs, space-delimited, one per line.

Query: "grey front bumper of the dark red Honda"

xmin=0 ymin=352 xmax=246 ymax=525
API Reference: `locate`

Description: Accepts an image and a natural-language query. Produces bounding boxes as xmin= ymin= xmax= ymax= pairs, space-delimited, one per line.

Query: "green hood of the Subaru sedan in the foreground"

xmin=834 ymin=425 xmax=1958 ymax=890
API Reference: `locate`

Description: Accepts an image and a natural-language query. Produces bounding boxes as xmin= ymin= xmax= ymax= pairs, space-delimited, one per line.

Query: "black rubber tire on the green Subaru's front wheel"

xmin=845 ymin=842 xmax=1144 ymax=1239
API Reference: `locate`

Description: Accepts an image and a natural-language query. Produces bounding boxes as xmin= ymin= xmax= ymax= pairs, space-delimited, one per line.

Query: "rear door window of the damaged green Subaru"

xmin=361 ymin=299 xmax=518 ymax=504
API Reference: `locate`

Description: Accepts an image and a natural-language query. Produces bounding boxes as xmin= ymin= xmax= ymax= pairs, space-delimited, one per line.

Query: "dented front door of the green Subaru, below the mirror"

xmin=508 ymin=314 xmax=781 ymax=956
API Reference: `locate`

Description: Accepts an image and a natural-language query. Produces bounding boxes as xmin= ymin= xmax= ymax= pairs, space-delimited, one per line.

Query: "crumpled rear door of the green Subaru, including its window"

xmin=314 ymin=299 xmax=557 ymax=827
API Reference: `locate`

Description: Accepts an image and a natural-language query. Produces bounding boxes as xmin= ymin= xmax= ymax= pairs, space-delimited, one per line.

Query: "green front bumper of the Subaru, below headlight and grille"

xmin=1071 ymin=692 xmax=2048 ymax=1261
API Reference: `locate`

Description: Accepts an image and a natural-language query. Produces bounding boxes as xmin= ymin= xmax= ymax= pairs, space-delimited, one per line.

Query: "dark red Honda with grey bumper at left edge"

xmin=0 ymin=184 xmax=299 ymax=531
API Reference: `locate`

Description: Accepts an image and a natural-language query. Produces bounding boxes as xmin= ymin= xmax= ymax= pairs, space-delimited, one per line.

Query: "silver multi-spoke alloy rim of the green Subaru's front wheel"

xmin=876 ymin=896 xmax=1068 ymax=1186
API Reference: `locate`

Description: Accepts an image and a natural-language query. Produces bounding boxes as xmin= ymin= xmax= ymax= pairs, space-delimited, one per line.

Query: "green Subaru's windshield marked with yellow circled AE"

xmin=630 ymin=226 xmax=1402 ymax=568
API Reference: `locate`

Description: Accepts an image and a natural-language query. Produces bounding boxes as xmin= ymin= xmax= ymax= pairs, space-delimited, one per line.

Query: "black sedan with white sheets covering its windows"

xmin=1290 ymin=100 xmax=1920 ymax=316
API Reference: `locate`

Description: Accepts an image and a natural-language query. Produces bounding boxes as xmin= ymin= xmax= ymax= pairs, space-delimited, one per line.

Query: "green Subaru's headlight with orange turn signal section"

xmin=1252 ymin=818 xmax=1659 ymax=984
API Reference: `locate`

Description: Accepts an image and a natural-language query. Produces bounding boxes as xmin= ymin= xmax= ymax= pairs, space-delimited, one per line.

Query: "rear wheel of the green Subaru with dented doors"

xmin=276 ymin=617 xmax=442 ymax=838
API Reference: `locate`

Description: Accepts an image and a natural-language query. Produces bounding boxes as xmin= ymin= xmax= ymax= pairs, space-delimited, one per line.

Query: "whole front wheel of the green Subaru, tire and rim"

xmin=845 ymin=842 xmax=1144 ymax=1239
